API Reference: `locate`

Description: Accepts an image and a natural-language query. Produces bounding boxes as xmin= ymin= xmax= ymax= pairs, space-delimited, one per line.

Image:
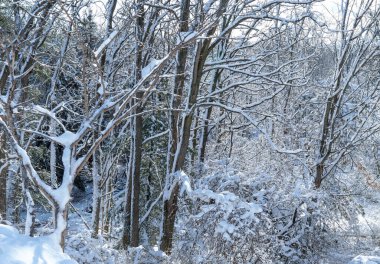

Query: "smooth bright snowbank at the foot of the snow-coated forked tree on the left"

xmin=0 ymin=224 xmax=77 ymax=264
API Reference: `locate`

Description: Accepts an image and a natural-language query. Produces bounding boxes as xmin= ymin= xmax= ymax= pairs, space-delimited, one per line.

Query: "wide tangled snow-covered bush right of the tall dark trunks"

xmin=172 ymin=158 xmax=358 ymax=263
